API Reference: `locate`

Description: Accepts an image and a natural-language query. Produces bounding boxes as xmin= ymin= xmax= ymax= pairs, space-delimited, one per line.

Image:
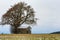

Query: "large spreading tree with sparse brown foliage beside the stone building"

xmin=2 ymin=2 xmax=36 ymax=34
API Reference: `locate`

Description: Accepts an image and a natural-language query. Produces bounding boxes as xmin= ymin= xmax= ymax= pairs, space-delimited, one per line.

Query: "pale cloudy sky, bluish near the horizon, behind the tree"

xmin=0 ymin=0 xmax=60 ymax=34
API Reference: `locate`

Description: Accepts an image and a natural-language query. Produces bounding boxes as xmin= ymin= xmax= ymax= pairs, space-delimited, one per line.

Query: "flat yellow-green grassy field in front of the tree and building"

xmin=0 ymin=34 xmax=60 ymax=40
